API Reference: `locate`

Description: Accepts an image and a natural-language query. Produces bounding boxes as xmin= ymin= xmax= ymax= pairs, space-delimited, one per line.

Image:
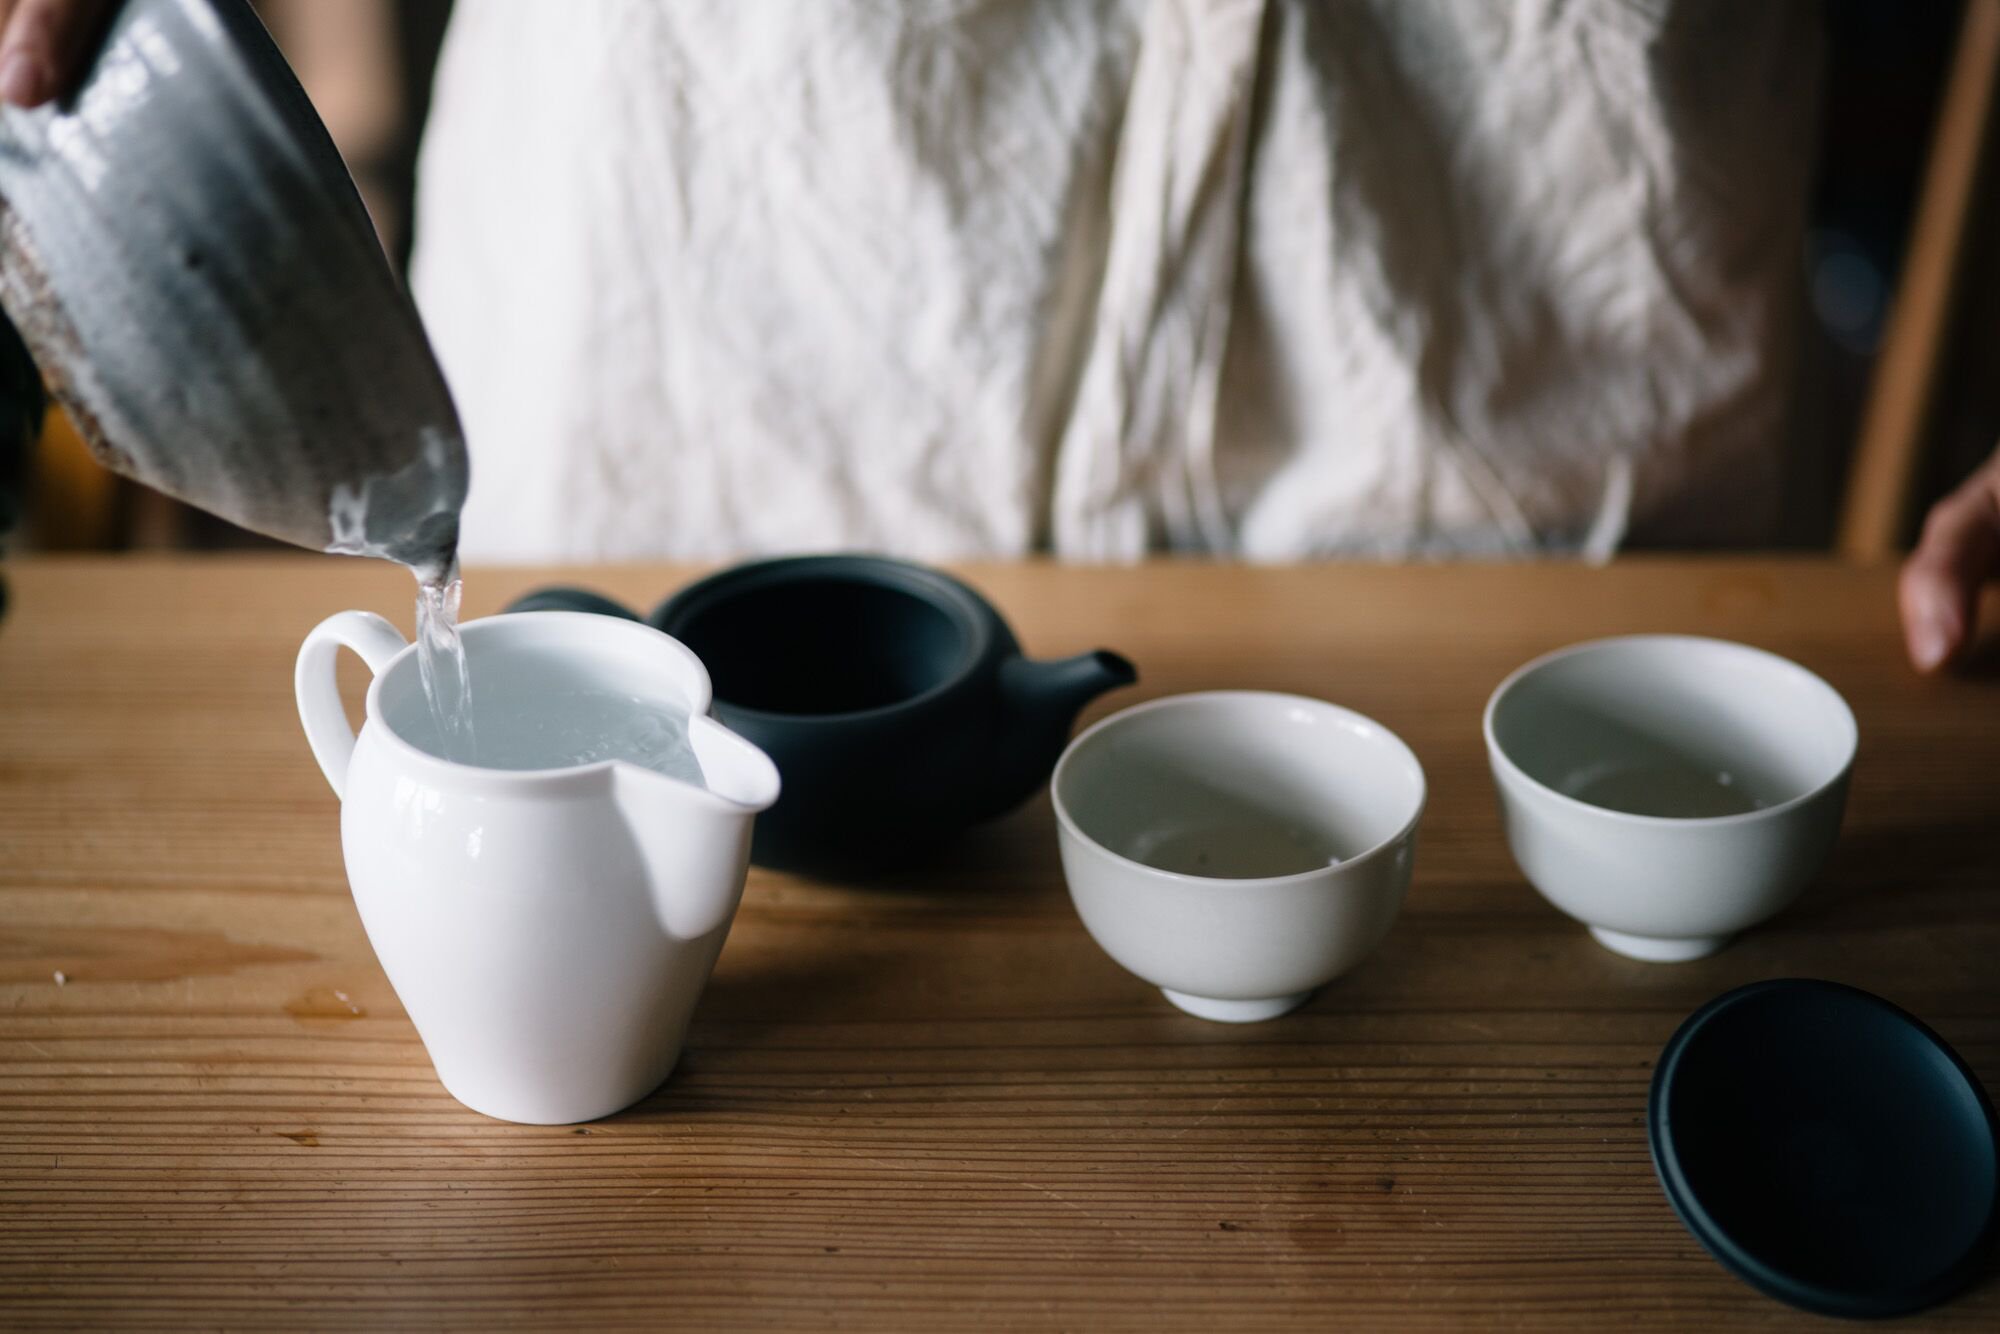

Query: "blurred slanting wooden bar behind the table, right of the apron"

xmin=1836 ymin=0 xmax=2000 ymax=564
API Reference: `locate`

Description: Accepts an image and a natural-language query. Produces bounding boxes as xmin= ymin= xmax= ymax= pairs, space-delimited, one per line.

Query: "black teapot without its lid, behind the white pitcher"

xmin=508 ymin=556 xmax=1138 ymax=874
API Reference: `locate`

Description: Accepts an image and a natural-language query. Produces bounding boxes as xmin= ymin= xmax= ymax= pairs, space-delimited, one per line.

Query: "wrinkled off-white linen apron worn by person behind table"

xmin=414 ymin=0 xmax=1818 ymax=560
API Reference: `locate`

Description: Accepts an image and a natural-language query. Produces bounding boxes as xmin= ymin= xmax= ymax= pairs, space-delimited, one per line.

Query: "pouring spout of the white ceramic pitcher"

xmin=612 ymin=718 xmax=778 ymax=940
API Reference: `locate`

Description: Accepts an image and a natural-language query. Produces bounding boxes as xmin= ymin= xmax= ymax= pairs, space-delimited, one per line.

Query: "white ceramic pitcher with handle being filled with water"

xmin=296 ymin=612 xmax=778 ymax=1124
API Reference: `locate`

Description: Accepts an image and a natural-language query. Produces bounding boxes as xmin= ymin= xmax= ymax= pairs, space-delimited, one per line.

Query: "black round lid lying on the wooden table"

xmin=1646 ymin=978 xmax=2000 ymax=1316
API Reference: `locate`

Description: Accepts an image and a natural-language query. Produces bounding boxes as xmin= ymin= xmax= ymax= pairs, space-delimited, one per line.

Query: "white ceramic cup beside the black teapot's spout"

xmin=1050 ymin=690 xmax=1424 ymax=1022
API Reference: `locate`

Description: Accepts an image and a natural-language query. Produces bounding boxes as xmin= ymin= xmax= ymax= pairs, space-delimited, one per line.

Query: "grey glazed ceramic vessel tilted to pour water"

xmin=0 ymin=0 xmax=468 ymax=566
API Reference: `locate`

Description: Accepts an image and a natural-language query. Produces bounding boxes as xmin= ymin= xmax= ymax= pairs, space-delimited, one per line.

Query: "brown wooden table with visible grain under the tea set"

xmin=0 ymin=558 xmax=2000 ymax=1330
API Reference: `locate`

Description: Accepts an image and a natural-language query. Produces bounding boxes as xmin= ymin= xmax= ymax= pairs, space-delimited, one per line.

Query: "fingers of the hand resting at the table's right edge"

xmin=1896 ymin=450 xmax=2000 ymax=672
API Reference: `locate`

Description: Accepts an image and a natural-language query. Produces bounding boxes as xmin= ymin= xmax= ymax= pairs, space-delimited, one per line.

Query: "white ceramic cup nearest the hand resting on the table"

xmin=1486 ymin=636 xmax=1856 ymax=962
